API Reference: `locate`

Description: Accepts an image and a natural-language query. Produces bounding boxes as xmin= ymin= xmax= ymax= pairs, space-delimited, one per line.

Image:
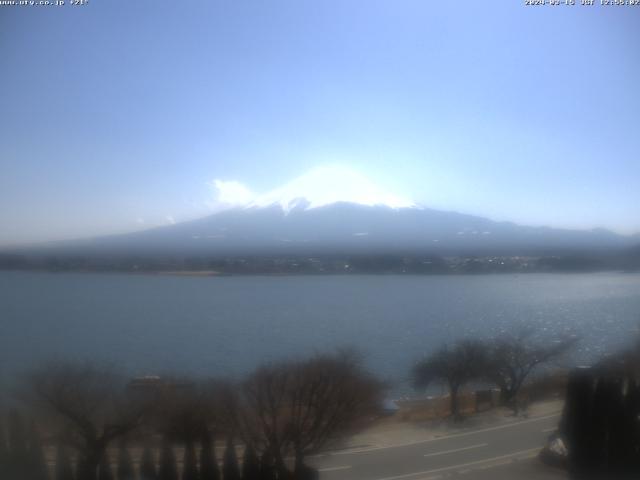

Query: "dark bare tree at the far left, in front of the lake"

xmin=29 ymin=363 xmax=149 ymax=480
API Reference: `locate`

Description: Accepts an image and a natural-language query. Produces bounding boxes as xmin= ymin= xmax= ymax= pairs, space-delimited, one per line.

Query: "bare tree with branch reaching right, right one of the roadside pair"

xmin=486 ymin=329 xmax=577 ymax=413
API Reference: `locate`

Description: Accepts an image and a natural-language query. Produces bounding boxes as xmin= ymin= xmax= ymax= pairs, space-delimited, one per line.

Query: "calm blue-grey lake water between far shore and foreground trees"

xmin=0 ymin=272 xmax=640 ymax=391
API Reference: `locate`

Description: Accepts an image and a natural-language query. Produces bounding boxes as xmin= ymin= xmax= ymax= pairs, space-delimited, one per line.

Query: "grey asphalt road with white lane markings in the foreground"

xmin=310 ymin=414 xmax=564 ymax=480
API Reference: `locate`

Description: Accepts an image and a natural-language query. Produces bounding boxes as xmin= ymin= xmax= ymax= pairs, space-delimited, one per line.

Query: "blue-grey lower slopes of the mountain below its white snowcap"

xmin=30 ymin=202 xmax=638 ymax=255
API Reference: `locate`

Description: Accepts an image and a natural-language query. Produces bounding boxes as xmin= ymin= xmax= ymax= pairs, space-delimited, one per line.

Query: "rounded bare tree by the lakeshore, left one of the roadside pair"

xmin=412 ymin=340 xmax=487 ymax=420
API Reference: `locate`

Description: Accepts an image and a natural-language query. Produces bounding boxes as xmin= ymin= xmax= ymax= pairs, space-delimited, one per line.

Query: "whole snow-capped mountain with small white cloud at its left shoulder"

xmin=8 ymin=166 xmax=640 ymax=256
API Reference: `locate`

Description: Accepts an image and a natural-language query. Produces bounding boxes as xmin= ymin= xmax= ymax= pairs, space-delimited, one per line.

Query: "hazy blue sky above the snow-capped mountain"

xmin=0 ymin=0 xmax=640 ymax=244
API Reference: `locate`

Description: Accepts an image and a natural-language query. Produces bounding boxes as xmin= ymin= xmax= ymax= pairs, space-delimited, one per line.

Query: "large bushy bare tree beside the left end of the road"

xmin=244 ymin=352 xmax=383 ymax=476
